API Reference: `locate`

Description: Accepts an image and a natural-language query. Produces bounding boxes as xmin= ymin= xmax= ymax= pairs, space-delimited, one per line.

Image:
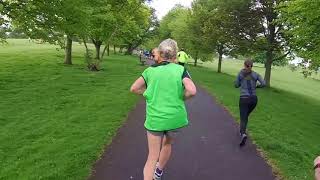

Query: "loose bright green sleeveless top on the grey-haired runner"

xmin=142 ymin=62 xmax=190 ymax=131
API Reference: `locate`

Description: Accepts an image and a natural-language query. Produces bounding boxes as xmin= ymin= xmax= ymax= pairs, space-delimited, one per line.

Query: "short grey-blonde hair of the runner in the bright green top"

xmin=158 ymin=39 xmax=178 ymax=61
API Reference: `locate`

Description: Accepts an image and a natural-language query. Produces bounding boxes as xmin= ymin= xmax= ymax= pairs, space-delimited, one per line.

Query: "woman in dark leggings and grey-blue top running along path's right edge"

xmin=235 ymin=60 xmax=266 ymax=146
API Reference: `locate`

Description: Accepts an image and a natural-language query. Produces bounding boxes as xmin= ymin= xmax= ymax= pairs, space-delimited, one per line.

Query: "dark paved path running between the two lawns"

xmin=90 ymin=88 xmax=275 ymax=180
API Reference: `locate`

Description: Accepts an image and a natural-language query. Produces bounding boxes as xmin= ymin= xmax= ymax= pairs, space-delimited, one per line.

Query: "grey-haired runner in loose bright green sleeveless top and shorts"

xmin=131 ymin=39 xmax=196 ymax=180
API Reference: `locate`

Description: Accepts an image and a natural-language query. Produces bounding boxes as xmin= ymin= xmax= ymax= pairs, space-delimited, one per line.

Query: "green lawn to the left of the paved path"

xmin=0 ymin=40 xmax=142 ymax=180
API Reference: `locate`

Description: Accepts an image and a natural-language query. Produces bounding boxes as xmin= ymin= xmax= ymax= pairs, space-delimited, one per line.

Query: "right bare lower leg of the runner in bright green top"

xmin=159 ymin=135 xmax=173 ymax=170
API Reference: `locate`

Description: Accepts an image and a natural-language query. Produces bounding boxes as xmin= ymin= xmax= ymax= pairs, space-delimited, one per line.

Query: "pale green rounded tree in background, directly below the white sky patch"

xmin=145 ymin=5 xmax=213 ymax=65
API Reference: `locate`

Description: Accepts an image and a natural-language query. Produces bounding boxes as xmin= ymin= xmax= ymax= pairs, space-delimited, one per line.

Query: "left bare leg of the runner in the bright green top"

xmin=143 ymin=132 xmax=162 ymax=180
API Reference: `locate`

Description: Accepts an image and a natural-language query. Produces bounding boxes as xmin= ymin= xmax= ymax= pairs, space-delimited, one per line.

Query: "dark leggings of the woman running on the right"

xmin=239 ymin=96 xmax=258 ymax=134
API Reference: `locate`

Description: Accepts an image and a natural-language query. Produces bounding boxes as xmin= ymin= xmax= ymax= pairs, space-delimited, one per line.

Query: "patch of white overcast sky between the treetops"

xmin=151 ymin=0 xmax=192 ymax=19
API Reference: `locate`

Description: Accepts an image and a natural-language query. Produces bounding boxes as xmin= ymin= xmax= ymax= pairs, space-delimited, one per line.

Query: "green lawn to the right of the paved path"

xmin=190 ymin=61 xmax=320 ymax=180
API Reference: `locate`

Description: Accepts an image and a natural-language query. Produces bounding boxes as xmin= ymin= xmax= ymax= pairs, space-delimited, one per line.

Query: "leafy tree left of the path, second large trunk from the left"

xmin=88 ymin=0 xmax=144 ymax=60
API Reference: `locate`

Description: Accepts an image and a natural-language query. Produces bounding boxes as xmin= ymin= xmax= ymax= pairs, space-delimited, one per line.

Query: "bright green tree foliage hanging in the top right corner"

xmin=279 ymin=0 xmax=320 ymax=71
